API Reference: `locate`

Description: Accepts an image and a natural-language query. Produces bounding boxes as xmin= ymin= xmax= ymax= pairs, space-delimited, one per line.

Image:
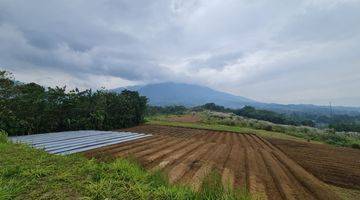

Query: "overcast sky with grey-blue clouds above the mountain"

xmin=0 ymin=0 xmax=360 ymax=106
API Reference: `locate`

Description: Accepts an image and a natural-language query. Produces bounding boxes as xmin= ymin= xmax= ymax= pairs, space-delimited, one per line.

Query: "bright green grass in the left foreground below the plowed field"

xmin=0 ymin=135 xmax=250 ymax=200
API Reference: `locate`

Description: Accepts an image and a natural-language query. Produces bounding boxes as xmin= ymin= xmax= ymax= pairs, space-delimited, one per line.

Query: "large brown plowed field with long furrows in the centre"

xmin=85 ymin=125 xmax=338 ymax=200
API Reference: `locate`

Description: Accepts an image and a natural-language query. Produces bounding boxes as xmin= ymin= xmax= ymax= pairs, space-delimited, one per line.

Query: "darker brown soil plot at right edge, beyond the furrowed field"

xmin=267 ymin=139 xmax=360 ymax=189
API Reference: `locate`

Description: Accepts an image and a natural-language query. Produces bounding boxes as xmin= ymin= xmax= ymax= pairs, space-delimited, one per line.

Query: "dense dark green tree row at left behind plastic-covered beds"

xmin=0 ymin=71 xmax=147 ymax=135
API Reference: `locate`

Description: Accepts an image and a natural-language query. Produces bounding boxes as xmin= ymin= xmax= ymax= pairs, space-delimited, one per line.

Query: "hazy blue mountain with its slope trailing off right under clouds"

xmin=111 ymin=82 xmax=360 ymax=115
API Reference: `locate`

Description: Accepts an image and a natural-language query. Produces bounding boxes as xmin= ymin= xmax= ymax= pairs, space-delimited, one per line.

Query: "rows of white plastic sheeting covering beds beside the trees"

xmin=10 ymin=130 xmax=151 ymax=155
